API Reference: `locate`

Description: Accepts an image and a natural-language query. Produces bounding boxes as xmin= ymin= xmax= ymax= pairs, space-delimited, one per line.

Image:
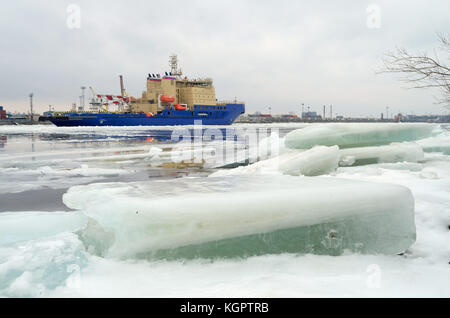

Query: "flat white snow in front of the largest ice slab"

xmin=48 ymin=254 xmax=449 ymax=298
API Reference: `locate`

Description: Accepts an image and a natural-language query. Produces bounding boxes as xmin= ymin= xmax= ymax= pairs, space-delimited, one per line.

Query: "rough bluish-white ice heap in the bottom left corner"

xmin=0 ymin=232 xmax=89 ymax=297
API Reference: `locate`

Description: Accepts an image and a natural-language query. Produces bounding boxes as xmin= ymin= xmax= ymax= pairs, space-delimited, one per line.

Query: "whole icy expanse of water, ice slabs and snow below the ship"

xmin=0 ymin=124 xmax=450 ymax=297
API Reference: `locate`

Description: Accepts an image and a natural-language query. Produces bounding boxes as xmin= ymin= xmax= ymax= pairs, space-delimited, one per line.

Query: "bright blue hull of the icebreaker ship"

xmin=46 ymin=104 xmax=245 ymax=126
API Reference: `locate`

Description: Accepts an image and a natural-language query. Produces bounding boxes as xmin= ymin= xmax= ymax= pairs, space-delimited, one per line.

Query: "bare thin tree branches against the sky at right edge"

xmin=382 ymin=35 xmax=450 ymax=108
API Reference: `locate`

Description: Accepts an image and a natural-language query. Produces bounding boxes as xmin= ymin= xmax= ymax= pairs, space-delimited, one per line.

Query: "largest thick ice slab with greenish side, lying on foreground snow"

xmin=63 ymin=176 xmax=415 ymax=258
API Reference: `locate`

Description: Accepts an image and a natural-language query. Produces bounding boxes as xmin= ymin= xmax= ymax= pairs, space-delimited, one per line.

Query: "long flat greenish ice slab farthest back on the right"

xmin=285 ymin=123 xmax=438 ymax=149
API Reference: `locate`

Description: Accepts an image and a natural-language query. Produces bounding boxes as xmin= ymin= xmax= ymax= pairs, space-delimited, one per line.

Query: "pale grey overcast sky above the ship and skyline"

xmin=0 ymin=0 xmax=450 ymax=116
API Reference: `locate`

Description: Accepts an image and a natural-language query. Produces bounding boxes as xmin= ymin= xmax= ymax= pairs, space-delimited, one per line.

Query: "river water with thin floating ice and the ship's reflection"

xmin=0 ymin=125 xmax=292 ymax=212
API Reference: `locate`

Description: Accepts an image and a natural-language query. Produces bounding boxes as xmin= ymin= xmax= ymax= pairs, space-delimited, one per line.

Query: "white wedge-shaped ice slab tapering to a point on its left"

xmin=210 ymin=146 xmax=339 ymax=177
